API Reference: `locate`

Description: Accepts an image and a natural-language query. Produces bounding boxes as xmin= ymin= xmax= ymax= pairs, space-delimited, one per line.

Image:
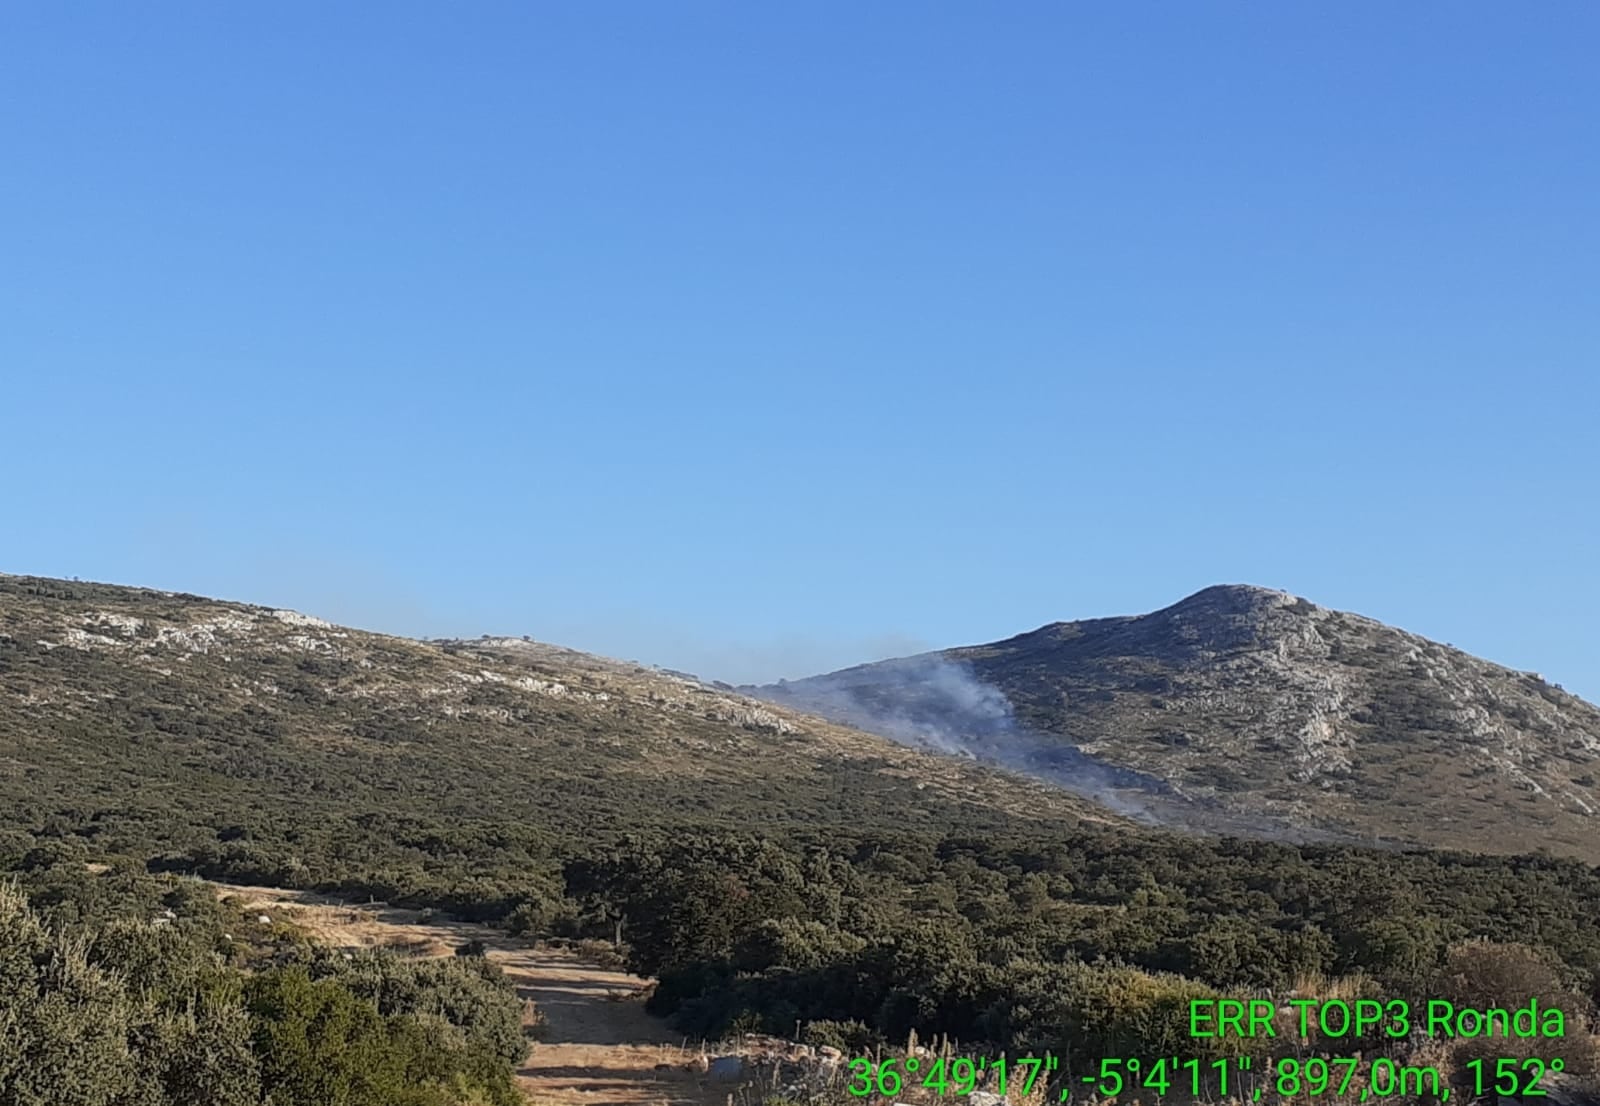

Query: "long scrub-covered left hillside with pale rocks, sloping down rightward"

xmin=0 ymin=576 xmax=1126 ymax=898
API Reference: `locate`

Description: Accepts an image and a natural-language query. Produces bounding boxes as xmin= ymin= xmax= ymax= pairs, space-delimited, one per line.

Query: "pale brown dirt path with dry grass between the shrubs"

xmin=218 ymin=884 xmax=731 ymax=1106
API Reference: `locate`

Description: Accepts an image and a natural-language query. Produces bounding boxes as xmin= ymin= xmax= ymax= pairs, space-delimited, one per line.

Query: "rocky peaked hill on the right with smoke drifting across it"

xmin=750 ymin=586 xmax=1600 ymax=863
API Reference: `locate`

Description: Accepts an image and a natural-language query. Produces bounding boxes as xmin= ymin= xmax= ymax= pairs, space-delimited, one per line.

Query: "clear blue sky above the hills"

xmin=0 ymin=0 xmax=1600 ymax=699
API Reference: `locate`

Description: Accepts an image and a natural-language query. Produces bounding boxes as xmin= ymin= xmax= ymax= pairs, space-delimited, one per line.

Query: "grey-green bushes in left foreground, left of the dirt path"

xmin=0 ymin=858 xmax=526 ymax=1106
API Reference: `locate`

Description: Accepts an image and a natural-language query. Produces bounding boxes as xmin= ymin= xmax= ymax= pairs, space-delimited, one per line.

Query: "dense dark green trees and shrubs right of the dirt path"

xmin=566 ymin=832 xmax=1600 ymax=1060
